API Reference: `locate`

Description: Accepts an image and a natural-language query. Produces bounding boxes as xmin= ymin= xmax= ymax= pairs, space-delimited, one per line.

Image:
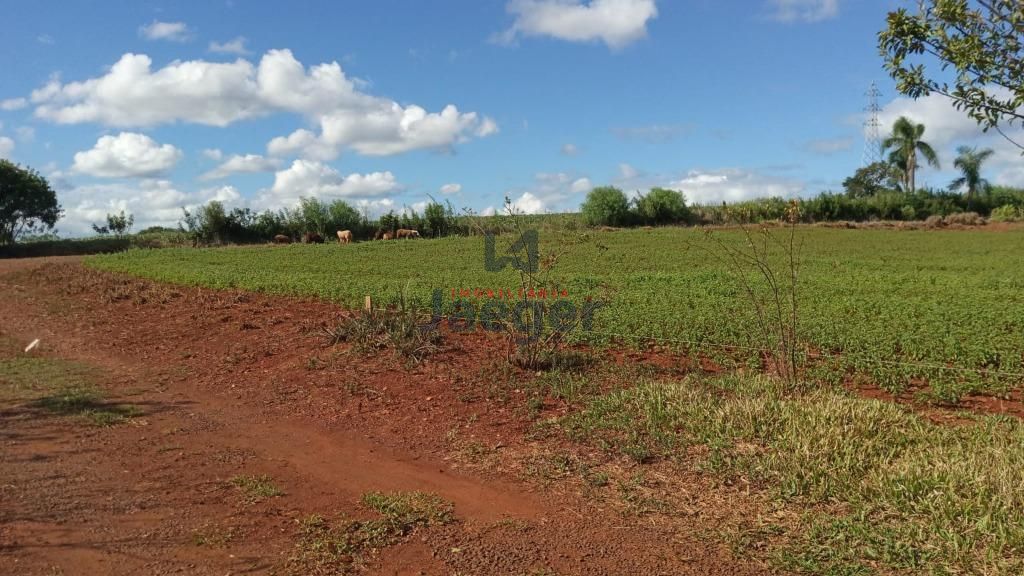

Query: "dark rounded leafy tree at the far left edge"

xmin=0 ymin=160 xmax=63 ymax=245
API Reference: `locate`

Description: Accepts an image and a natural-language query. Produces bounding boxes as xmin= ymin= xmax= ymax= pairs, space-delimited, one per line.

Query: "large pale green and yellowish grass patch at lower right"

xmin=561 ymin=377 xmax=1024 ymax=574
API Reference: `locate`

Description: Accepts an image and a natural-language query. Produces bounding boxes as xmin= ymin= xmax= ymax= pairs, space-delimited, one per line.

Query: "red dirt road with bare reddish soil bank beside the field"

xmin=0 ymin=259 xmax=765 ymax=576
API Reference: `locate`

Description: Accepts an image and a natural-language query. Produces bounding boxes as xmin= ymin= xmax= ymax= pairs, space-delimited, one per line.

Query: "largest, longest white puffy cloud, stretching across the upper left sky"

xmin=25 ymin=50 xmax=498 ymax=160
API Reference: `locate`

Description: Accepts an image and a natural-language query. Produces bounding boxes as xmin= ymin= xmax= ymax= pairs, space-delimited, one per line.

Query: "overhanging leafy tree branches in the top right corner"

xmin=879 ymin=0 xmax=1024 ymax=148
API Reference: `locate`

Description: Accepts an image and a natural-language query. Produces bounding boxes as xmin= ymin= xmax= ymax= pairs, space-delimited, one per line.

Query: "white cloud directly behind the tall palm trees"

xmin=879 ymin=94 xmax=1024 ymax=188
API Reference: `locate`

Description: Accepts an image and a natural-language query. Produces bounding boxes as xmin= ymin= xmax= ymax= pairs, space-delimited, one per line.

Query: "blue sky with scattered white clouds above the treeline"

xmin=0 ymin=0 xmax=1024 ymax=235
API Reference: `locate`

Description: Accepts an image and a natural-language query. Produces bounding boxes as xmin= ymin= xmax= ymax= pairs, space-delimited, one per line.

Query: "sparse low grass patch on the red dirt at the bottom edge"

xmin=288 ymin=492 xmax=455 ymax=576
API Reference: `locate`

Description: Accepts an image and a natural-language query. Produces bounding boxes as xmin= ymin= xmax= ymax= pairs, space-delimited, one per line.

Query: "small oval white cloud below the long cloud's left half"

xmin=72 ymin=132 xmax=181 ymax=178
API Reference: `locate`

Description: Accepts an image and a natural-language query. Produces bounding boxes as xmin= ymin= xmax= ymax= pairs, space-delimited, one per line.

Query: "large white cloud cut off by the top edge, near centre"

xmin=494 ymin=0 xmax=657 ymax=48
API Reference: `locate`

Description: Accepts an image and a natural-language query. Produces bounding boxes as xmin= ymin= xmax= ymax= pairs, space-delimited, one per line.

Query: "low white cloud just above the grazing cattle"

xmin=260 ymin=160 xmax=401 ymax=207
